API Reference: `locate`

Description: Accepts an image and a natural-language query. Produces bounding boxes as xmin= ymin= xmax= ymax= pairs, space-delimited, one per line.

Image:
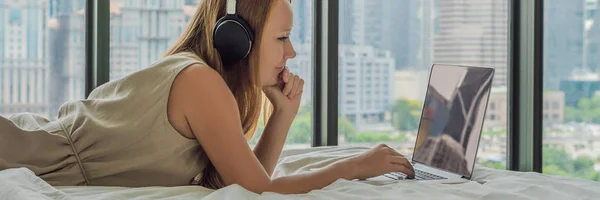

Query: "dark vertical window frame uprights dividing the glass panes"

xmin=85 ymin=0 xmax=544 ymax=172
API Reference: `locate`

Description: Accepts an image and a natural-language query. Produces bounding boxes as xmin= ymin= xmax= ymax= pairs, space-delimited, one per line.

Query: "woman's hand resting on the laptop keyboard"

xmin=342 ymin=144 xmax=415 ymax=180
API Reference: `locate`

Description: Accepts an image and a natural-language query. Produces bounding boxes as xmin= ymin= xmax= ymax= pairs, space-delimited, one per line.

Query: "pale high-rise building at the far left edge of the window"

xmin=0 ymin=1 xmax=50 ymax=115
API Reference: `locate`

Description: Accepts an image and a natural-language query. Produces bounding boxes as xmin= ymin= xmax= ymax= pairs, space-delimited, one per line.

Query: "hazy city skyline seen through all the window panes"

xmin=0 ymin=0 xmax=600 ymax=183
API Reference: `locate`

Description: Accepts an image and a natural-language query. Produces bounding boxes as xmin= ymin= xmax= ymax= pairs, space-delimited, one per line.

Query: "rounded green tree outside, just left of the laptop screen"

xmin=392 ymin=99 xmax=422 ymax=131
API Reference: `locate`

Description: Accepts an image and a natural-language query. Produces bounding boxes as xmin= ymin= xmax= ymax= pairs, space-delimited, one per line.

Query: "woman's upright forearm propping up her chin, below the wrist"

xmin=254 ymin=110 xmax=292 ymax=176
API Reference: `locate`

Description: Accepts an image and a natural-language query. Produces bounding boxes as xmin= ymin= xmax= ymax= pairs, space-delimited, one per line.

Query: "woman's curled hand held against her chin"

xmin=263 ymin=67 xmax=304 ymax=117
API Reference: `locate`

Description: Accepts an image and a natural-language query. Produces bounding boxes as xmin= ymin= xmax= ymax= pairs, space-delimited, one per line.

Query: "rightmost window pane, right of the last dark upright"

xmin=542 ymin=0 xmax=600 ymax=181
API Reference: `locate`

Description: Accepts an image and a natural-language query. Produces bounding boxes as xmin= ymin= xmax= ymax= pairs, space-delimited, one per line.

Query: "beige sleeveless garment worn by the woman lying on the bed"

xmin=0 ymin=53 xmax=207 ymax=186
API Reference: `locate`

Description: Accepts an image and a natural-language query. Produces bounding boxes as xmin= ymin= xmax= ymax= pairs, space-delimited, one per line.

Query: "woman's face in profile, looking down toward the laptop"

xmin=259 ymin=0 xmax=296 ymax=86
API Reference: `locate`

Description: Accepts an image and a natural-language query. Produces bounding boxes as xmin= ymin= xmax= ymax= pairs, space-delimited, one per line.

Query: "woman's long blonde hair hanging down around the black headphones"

xmin=165 ymin=0 xmax=273 ymax=189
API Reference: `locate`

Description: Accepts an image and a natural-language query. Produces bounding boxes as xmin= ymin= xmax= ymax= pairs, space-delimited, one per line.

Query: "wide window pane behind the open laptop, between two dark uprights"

xmin=338 ymin=0 xmax=510 ymax=168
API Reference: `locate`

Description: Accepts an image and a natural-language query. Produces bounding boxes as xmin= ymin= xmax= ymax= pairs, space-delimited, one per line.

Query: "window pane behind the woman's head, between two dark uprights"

xmin=110 ymin=0 xmax=313 ymax=148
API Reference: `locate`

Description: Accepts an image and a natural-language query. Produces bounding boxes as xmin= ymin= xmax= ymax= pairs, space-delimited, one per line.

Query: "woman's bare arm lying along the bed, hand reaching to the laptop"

xmin=174 ymin=65 xmax=410 ymax=194
